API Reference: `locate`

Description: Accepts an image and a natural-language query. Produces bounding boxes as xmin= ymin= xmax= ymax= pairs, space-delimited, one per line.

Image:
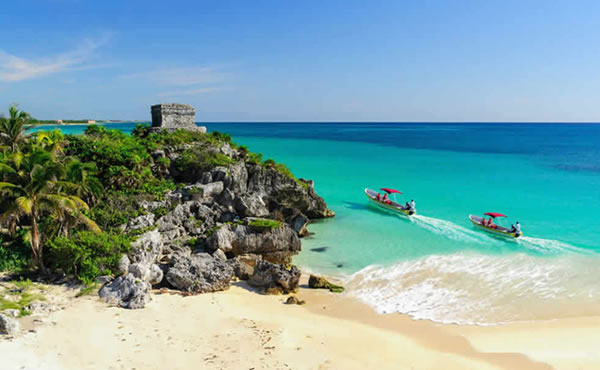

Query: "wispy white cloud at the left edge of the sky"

xmin=0 ymin=36 xmax=109 ymax=82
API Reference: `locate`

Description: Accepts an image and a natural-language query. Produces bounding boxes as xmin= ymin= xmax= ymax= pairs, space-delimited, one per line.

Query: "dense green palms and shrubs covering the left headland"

xmin=0 ymin=105 xmax=304 ymax=284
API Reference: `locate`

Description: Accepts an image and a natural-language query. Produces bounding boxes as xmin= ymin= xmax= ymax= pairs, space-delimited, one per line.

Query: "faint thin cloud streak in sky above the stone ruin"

xmin=121 ymin=66 xmax=227 ymax=86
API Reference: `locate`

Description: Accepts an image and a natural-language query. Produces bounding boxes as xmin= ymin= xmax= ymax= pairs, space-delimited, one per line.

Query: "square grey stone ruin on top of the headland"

xmin=150 ymin=103 xmax=206 ymax=132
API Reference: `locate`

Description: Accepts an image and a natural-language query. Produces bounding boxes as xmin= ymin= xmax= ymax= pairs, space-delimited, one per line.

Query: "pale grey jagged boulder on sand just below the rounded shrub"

xmin=98 ymin=274 xmax=151 ymax=309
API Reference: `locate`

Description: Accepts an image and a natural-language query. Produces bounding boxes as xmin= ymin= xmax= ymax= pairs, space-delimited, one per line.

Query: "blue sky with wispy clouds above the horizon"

xmin=0 ymin=0 xmax=600 ymax=122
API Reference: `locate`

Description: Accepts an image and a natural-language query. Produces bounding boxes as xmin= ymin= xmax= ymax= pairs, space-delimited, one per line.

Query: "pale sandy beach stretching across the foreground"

xmin=0 ymin=283 xmax=600 ymax=369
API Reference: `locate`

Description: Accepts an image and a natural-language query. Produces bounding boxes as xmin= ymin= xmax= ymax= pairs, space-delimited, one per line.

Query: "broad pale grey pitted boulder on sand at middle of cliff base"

xmin=166 ymin=253 xmax=233 ymax=293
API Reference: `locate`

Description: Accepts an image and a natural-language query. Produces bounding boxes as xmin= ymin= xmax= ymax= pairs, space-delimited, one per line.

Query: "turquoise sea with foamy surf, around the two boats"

xmin=32 ymin=123 xmax=600 ymax=325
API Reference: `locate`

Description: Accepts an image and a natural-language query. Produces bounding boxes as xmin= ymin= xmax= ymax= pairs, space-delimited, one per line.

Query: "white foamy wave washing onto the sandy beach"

xmin=346 ymin=253 xmax=600 ymax=325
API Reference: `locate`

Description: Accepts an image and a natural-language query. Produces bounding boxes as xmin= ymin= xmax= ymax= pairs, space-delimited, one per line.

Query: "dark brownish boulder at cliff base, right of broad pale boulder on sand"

xmin=248 ymin=261 xmax=301 ymax=294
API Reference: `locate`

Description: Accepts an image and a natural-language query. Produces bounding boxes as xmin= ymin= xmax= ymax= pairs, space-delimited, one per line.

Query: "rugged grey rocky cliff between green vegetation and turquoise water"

xmin=100 ymin=137 xmax=334 ymax=308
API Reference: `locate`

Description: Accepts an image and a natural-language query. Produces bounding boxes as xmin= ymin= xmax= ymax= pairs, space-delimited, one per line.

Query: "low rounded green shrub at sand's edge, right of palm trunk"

xmin=46 ymin=231 xmax=132 ymax=284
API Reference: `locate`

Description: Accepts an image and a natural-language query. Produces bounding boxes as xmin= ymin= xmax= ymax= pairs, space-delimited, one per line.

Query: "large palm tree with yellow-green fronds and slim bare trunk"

xmin=0 ymin=148 xmax=99 ymax=274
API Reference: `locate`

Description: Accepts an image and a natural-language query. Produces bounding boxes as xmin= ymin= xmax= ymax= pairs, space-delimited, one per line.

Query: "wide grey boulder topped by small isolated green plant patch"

xmin=206 ymin=224 xmax=301 ymax=263
